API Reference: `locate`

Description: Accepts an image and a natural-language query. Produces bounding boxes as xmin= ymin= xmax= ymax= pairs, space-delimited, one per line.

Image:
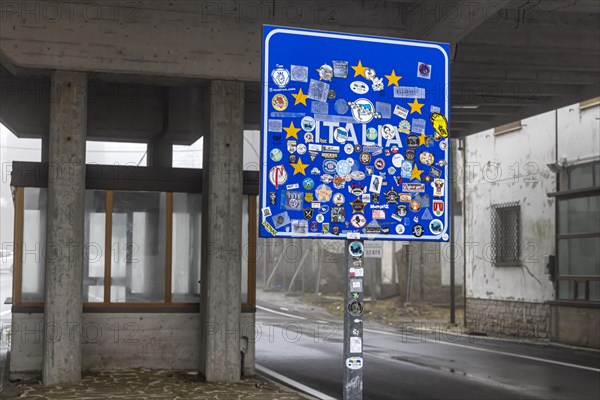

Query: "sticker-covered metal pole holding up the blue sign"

xmin=344 ymin=240 xmax=364 ymax=400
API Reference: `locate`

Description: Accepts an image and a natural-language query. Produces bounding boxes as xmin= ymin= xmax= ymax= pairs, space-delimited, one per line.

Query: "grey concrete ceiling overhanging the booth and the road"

xmin=0 ymin=0 xmax=600 ymax=143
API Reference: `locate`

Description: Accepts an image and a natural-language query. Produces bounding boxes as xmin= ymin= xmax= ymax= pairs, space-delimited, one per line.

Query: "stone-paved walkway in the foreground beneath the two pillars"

xmin=0 ymin=369 xmax=308 ymax=400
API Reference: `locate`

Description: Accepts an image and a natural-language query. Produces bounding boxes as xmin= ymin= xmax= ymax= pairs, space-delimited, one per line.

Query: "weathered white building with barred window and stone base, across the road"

xmin=460 ymin=98 xmax=600 ymax=348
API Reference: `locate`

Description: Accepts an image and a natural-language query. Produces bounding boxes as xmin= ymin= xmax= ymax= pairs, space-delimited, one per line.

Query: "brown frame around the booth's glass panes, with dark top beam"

xmin=11 ymin=162 xmax=258 ymax=312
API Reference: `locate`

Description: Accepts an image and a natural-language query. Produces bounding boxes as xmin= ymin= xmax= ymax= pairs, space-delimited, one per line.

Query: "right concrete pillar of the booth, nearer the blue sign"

xmin=199 ymin=81 xmax=244 ymax=382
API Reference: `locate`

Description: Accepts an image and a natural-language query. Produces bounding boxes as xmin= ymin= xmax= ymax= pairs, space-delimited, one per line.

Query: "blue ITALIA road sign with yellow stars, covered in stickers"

xmin=260 ymin=26 xmax=450 ymax=241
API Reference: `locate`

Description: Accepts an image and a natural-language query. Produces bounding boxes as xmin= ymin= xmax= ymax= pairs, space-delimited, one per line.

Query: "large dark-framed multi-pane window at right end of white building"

xmin=552 ymin=162 xmax=600 ymax=302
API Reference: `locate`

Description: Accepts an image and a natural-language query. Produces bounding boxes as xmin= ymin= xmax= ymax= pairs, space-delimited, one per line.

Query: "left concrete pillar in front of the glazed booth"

xmin=42 ymin=71 xmax=87 ymax=385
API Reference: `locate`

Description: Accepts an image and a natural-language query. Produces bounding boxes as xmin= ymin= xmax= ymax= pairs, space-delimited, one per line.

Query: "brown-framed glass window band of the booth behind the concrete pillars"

xmin=11 ymin=162 xmax=258 ymax=312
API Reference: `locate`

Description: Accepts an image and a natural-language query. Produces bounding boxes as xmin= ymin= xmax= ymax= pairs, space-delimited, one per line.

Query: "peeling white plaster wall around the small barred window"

xmin=464 ymin=104 xmax=600 ymax=302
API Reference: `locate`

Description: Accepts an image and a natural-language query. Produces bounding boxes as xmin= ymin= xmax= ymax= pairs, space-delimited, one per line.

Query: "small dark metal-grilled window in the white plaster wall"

xmin=492 ymin=202 xmax=521 ymax=267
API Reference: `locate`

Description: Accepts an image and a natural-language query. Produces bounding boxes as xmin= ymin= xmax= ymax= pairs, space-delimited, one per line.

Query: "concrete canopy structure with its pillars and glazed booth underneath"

xmin=0 ymin=0 xmax=600 ymax=384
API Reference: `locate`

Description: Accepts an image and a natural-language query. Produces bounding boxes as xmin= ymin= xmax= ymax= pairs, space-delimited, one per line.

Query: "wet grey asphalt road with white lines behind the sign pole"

xmin=256 ymin=305 xmax=600 ymax=400
